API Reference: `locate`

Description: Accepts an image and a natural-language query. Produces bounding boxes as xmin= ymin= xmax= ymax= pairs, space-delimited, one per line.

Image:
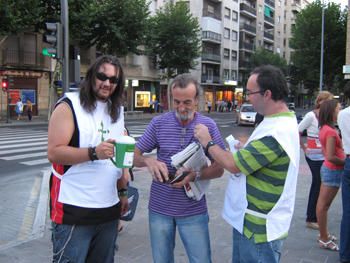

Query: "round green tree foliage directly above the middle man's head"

xmin=147 ymin=0 xmax=200 ymax=79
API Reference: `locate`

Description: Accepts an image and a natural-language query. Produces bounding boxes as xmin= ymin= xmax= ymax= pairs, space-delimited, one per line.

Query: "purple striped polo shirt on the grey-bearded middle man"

xmin=136 ymin=111 xmax=225 ymax=218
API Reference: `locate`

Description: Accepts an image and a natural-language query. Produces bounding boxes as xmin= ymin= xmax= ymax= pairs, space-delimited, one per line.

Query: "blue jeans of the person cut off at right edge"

xmin=339 ymin=158 xmax=350 ymax=262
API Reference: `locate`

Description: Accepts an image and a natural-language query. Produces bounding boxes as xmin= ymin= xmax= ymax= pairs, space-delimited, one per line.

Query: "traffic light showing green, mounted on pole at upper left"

xmin=43 ymin=22 xmax=63 ymax=59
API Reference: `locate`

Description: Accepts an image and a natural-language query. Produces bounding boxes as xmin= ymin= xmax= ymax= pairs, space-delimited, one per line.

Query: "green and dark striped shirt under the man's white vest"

xmin=233 ymin=136 xmax=290 ymax=243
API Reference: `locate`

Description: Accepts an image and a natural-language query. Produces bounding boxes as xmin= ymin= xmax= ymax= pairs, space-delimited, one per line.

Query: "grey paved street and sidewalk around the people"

xmin=0 ymin=110 xmax=342 ymax=263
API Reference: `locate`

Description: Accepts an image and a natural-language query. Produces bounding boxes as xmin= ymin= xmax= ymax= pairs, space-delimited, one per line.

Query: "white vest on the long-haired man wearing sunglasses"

xmin=53 ymin=93 xmax=124 ymax=208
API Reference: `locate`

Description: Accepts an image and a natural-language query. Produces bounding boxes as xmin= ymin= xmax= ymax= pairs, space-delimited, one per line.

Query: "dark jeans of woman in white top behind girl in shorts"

xmin=305 ymin=155 xmax=323 ymax=223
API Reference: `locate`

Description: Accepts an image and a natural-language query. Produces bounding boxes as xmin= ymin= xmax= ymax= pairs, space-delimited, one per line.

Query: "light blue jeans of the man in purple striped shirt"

xmin=149 ymin=211 xmax=211 ymax=263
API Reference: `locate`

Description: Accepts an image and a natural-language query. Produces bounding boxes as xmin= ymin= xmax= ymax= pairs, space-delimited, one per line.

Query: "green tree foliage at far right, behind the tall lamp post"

xmin=290 ymin=0 xmax=347 ymax=95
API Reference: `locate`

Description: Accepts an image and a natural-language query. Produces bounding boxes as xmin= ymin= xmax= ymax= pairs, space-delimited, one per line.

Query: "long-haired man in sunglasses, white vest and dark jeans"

xmin=47 ymin=55 xmax=129 ymax=263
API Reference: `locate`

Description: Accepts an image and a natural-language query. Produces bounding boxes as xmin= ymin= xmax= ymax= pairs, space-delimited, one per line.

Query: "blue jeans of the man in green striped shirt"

xmin=232 ymin=228 xmax=286 ymax=263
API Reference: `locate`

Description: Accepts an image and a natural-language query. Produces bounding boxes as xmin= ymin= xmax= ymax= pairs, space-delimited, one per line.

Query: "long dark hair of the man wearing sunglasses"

xmin=79 ymin=55 xmax=125 ymax=122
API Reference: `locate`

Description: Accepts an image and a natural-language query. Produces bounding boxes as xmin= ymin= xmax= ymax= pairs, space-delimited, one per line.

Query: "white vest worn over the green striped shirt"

xmin=222 ymin=116 xmax=300 ymax=242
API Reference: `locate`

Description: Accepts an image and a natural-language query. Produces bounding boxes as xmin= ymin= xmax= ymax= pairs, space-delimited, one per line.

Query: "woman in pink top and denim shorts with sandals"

xmin=316 ymin=100 xmax=345 ymax=251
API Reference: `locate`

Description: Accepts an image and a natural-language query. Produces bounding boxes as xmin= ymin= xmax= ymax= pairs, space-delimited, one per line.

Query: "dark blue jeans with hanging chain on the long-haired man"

xmin=51 ymin=219 xmax=119 ymax=263
